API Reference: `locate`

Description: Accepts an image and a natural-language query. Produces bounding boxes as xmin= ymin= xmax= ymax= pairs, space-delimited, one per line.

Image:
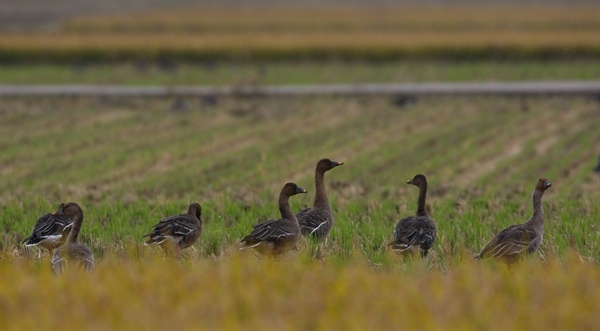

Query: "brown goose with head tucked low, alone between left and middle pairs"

xmin=142 ymin=202 xmax=202 ymax=254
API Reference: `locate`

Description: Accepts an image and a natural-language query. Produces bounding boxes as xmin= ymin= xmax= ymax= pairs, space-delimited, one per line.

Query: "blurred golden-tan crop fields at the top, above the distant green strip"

xmin=0 ymin=6 xmax=600 ymax=60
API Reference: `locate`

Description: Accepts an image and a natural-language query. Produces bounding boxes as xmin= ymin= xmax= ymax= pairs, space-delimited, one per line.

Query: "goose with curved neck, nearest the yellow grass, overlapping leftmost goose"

xmin=52 ymin=202 xmax=94 ymax=274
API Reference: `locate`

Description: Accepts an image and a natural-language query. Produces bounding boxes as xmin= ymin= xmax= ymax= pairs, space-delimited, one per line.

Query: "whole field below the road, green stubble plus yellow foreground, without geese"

xmin=0 ymin=93 xmax=600 ymax=329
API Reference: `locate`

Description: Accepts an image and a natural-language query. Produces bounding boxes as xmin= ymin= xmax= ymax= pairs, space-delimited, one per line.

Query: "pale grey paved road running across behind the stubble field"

xmin=0 ymin=81 xmax=600 ymax=97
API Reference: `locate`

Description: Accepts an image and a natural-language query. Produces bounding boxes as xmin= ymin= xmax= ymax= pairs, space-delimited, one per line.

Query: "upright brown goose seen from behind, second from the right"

xmin=389 ymin=174 xmax=436 ymax=257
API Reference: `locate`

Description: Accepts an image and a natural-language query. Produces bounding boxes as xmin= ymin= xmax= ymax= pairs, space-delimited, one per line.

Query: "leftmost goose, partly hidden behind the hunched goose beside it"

xmin=23 ymin=203 xmax=72 ymax=256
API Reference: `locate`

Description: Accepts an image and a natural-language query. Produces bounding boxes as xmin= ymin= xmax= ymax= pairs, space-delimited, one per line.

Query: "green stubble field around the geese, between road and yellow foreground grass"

xmin=0 ymin=97 xmax=600 ymax=261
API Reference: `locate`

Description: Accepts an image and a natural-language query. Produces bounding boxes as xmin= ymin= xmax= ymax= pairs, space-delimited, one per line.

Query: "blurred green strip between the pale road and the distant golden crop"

xmin=0 ymin=60 xmax=600 ymax=86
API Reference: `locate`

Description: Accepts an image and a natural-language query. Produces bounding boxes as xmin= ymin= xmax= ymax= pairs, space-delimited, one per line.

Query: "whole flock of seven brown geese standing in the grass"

xmin=23 ymin=159 xmax=552 ymax=273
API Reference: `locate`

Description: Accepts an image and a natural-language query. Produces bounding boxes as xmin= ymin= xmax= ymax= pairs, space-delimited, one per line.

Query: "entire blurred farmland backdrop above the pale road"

xmin=0 ymin=0 xmax=600 ymax=85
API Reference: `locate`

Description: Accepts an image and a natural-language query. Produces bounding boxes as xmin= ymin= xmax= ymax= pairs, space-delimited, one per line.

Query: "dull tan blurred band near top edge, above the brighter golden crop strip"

xmin=64 ymin=5 xmax=598 ymax=32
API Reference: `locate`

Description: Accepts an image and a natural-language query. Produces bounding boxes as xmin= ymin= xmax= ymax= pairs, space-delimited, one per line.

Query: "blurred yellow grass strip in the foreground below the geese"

xmin=0 ymin=254 xmax=600 ymax=330
